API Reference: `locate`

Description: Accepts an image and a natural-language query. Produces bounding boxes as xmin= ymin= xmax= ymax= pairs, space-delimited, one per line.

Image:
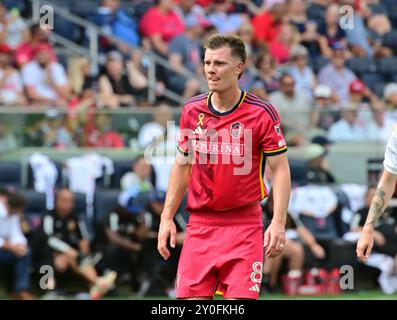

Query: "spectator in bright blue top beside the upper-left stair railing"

xmin=89 ymin=0 xmax=140 ymax=50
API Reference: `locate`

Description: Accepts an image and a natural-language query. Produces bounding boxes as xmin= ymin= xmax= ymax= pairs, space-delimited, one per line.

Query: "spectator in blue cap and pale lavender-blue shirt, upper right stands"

xmin=318 ymin=42 xmax=357 ymax=106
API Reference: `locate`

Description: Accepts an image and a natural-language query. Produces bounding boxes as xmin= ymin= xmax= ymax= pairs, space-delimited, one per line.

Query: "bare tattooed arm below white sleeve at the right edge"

xmin=356 ymin=170 xmax=397 ymax=262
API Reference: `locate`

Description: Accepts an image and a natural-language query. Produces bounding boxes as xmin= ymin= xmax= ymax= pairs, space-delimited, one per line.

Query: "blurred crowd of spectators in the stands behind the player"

xmin=0 ymin=0 xmax=397 ymax=147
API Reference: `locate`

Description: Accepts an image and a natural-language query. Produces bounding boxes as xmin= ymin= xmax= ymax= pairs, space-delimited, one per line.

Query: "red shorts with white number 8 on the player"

xmin=175 ymin=204 xmax=263 ymax=299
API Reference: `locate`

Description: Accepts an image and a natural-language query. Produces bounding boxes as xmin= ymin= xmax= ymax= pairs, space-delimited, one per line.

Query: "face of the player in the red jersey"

xmin=204 ymin=47 xmax=244 ymax=92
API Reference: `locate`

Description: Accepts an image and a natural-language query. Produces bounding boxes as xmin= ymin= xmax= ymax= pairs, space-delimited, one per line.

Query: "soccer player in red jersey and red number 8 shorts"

xmin=158 ymin=34 xmax=291 ymax=299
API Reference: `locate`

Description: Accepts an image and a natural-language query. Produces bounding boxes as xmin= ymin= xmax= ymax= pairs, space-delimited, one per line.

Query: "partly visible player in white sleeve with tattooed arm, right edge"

xmin=356 ymin=130 xmax=397 ymax=262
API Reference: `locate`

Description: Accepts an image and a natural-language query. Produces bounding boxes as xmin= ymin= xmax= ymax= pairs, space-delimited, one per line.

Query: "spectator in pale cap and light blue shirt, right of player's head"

xmin=289 ymin=45 xmax=317 ymax=100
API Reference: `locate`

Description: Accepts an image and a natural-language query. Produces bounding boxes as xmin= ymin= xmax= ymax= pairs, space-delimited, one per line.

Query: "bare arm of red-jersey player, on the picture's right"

xmin=264 ymin=153 xmax=291 ymax=258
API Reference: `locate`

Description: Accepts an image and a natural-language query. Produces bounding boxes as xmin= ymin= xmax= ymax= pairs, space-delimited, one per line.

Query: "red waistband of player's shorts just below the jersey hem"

xmin=189 ymin=203 xmax=263 ymax=226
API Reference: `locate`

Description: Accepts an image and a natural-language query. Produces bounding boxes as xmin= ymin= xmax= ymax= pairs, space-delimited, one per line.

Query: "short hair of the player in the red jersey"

xmin=204 ymin=33 xmax=247 ymax=79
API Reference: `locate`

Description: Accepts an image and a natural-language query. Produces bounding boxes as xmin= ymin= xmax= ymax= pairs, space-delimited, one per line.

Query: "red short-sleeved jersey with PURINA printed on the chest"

xmin=178 ymin=91 xmax=287 ymax=212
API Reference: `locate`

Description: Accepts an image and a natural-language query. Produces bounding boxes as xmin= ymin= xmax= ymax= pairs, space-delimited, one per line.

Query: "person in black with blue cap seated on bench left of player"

xmin=102 ymin=189 xmax=150 ymax=292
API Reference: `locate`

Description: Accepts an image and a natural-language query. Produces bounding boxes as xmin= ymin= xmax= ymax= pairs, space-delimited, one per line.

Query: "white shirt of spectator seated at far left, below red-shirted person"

xmin=22 ymin=60 xmax=68 ymax=99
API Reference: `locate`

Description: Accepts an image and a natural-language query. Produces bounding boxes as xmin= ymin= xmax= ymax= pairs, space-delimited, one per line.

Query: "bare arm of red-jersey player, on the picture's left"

xmin=157 ymin=154 xmax=191 ymax=260
